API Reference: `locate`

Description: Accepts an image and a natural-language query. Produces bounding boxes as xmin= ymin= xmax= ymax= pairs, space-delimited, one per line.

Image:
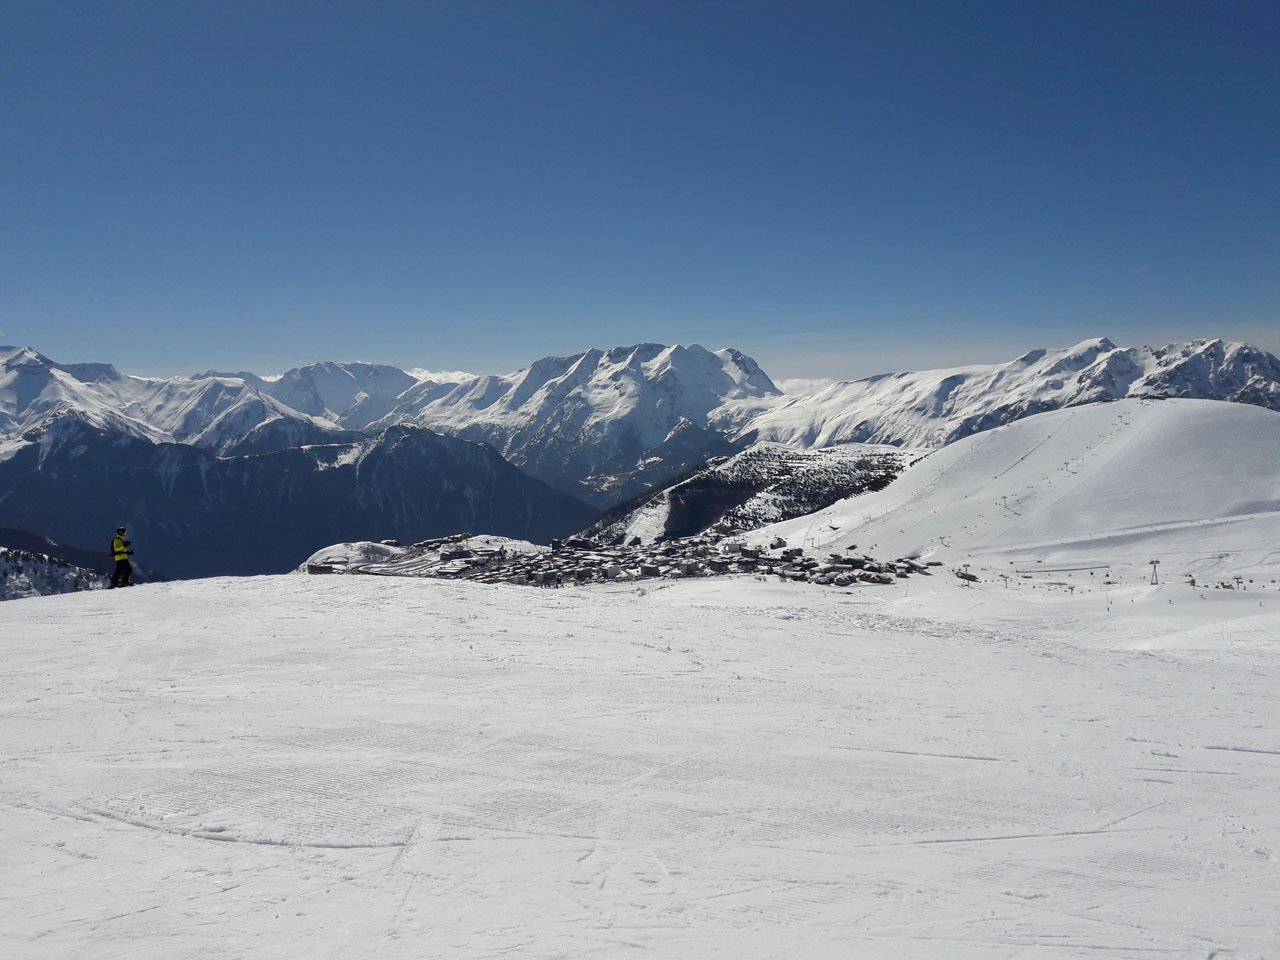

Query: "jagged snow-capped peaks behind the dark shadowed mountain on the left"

xmin=0 ymin=343 xmax=780 ymax=507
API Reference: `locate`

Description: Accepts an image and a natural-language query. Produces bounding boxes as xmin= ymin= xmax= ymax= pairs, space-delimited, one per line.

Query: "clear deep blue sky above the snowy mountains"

xmin=0 ymin=0 xmax=1280 ymax=376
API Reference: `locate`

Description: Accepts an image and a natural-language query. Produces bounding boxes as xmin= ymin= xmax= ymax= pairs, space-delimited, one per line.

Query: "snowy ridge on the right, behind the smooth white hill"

xmin=713 ymin=339 xmax=1280 ymax=447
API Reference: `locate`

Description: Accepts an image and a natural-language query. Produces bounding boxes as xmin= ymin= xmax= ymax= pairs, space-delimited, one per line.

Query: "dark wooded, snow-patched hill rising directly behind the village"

xmin=581 ymin=443 xmax=923 ymax=544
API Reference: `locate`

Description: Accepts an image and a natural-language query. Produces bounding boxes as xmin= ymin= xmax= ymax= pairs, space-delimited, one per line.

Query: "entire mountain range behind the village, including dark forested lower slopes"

xmin=0 ymin=339 xmax=1280 ymax=576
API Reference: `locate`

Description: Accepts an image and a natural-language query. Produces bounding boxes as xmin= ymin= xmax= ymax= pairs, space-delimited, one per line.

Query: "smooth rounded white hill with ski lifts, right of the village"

xmin=756 ymin=399 xmax=1280 ymax=572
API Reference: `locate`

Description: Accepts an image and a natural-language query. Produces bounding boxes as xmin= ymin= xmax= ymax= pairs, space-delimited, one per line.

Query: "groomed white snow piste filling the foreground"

xmin=0 ymin=576 xmax=1280 ymax=960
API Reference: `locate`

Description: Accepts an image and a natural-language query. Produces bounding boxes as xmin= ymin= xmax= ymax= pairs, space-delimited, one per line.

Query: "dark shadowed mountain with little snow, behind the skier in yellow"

xmin=0 ymin=417 xmax=594 ymax=577
